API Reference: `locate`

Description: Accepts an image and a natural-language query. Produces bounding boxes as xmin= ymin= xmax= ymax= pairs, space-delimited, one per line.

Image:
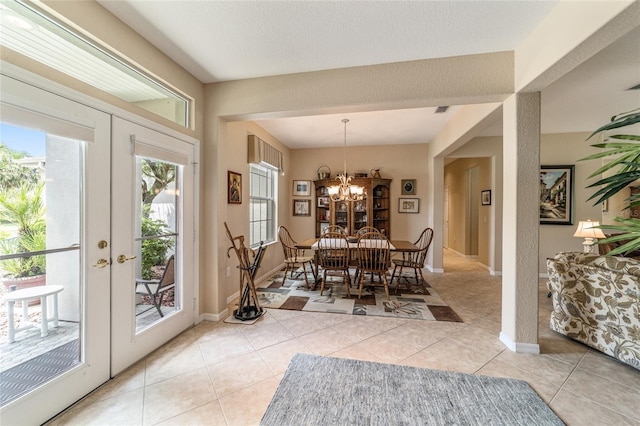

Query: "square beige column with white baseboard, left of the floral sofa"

xmin=500 ymin=92 xmax=540 ymax=353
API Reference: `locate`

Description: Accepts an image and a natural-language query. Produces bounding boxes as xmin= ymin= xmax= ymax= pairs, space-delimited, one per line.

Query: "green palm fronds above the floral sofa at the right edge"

xmin=583 ymin=108 xmax=640 ymax=255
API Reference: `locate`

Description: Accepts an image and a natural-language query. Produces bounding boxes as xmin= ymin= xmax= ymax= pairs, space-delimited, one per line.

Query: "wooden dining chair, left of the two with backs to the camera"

xmin=316 ymin=232 xmax=351 ymax=296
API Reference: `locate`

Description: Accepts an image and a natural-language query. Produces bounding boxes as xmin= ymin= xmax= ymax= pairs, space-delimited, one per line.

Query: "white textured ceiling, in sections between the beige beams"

xmin=98 ymin=0 xmax=640 ymax=148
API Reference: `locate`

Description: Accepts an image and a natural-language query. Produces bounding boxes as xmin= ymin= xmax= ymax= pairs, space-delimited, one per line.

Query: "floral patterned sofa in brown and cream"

xmin=547 ymin=252 xmax=640 ymax=370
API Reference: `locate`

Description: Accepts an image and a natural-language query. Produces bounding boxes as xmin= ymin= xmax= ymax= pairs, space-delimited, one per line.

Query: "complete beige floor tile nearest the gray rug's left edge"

xmin=208 ymin=352 xmax=273 ymax=398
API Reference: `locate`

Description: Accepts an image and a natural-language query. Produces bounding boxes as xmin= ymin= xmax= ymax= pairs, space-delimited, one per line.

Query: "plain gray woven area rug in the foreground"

xmin=260 ymin=354 xmax=564 ymax=426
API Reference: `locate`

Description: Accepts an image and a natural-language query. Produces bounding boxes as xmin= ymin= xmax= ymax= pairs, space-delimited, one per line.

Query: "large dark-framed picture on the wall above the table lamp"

xmin=540 ymin=165 xmax=574 ymax=225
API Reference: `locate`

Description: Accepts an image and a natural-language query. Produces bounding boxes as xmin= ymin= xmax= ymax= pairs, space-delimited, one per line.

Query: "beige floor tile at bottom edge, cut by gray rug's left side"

xmin=220 ymin=377 xmax=280 ymax=426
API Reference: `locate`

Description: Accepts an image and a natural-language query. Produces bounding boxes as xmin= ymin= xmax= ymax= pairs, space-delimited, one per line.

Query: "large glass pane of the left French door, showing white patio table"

xmin=0 ymin=123 xmax=85 ymax=405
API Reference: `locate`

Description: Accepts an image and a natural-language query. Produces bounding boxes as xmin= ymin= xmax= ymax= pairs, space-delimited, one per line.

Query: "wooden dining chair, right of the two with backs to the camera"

xmin=357 ymin=232 xmax=391 ymax=300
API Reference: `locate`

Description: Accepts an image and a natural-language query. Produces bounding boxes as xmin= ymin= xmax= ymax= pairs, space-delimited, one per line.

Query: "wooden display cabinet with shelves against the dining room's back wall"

xmin=313 ymin=178 xmax=391 ymax=238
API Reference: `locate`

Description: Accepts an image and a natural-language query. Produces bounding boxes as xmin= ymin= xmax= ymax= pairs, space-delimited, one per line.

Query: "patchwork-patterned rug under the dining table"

xmin=256 ymin=269 xmax=462 ymax=322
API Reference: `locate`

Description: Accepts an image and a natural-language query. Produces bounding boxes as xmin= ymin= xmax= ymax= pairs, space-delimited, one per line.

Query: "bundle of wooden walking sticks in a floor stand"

xmin=224 ymin=222 xmax=266 ymax=321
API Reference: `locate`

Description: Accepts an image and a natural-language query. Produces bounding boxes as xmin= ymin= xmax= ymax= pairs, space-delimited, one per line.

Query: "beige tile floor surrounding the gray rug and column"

xmin=48 ymin=254 xmax=640 ymax=426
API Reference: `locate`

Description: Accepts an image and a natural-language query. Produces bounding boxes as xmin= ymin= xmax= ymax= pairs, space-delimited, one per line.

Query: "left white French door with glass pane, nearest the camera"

xmin=0 ymin=76 xmax=111 ymax=425
